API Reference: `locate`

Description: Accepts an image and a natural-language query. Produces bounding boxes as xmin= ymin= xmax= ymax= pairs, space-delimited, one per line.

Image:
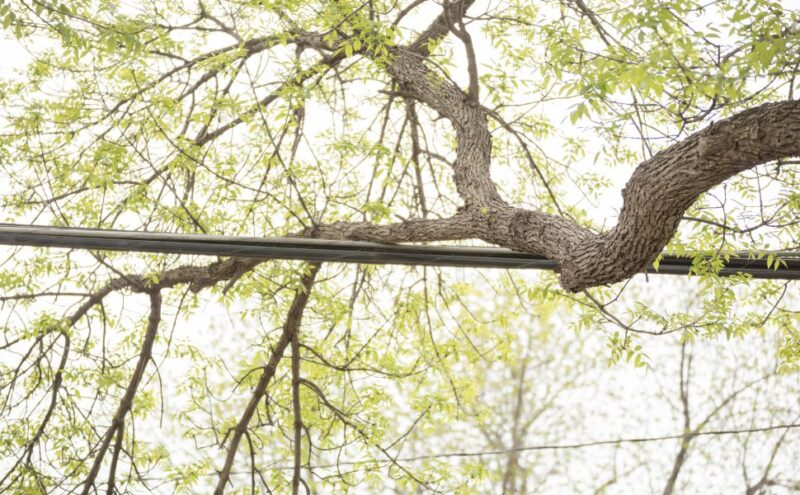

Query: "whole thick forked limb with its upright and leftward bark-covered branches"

xmin=302 ymin=0 xmax=800 ymax=292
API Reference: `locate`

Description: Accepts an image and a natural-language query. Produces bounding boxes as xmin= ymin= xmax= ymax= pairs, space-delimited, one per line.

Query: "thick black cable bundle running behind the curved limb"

xmin=0 ymin=224 xmax=800 ymax=280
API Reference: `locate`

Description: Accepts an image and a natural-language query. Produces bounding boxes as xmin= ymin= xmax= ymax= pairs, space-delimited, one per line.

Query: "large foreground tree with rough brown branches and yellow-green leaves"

xmin=0 ymin=0 xmax=800 ymax=494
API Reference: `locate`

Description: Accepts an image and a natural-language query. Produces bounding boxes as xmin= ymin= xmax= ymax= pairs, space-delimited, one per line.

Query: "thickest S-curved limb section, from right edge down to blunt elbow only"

xmin=558 ymin=101 xmax=800 ymax=290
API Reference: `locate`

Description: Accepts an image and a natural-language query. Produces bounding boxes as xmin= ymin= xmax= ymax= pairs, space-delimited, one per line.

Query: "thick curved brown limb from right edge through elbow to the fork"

xmin=462 ymin=101 xmax=800 ymax=291
